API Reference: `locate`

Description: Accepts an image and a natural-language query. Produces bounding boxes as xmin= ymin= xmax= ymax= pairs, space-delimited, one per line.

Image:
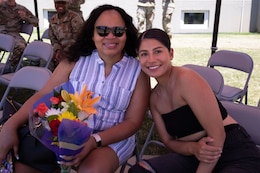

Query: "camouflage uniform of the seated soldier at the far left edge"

xmin=0 ymin=2 xmax=39 ymax=69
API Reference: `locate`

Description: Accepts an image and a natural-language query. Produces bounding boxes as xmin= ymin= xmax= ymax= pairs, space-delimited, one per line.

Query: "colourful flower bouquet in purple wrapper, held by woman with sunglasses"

xmin=29 ymin=82 xmax=100 ymax=172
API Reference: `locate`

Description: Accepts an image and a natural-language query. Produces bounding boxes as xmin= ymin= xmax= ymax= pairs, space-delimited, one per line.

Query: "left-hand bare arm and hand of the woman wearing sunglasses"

xmin=0 ymin=60 xmax=74 ymax=163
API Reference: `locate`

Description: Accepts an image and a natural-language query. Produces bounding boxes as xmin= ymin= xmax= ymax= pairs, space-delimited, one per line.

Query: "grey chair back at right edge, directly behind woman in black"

xmin=221 ymin=101 xmax=260 ymax=150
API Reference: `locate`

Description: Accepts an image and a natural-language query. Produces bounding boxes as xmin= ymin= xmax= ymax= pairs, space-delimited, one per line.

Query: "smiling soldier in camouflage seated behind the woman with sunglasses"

xmin=49 ymin=0 xmax=84 ymax=70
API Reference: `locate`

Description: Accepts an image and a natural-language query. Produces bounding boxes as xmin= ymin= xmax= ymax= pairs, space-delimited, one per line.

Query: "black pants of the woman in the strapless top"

xmin=129 ymin=124 xmax=260 ymax=173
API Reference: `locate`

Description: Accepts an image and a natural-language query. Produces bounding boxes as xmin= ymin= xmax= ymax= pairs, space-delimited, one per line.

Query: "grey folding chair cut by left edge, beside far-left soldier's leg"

xmin=0 ymin=34 xmax=15 ymax=75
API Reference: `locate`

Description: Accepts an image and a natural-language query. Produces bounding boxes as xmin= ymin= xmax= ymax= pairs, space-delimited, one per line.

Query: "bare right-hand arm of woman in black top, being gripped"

xmin=180 ymin=70 xmax=225 ymax=173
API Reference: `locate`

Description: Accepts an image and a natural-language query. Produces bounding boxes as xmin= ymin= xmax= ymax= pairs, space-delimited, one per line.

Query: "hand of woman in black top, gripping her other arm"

xmin=194 ymin=137 xmax=222 ymax=163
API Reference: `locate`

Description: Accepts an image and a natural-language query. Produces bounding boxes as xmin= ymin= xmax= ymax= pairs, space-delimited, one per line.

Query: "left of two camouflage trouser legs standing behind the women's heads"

xmin=137 ymin=0 xmax=155 ymax=34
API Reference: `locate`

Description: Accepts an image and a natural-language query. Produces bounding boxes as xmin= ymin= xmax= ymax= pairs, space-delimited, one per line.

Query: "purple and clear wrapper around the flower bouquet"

xmin=29 ymin=82 xmax=93 ymax=161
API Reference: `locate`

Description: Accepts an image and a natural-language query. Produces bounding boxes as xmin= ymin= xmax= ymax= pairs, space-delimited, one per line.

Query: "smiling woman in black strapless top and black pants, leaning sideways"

xmin=129 ymin=29 xmax=260 ymax=173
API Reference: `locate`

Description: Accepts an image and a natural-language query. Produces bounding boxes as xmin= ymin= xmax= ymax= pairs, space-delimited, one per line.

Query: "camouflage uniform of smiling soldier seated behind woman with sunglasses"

xmin=49 ymin=10 xmax=84 ymax=68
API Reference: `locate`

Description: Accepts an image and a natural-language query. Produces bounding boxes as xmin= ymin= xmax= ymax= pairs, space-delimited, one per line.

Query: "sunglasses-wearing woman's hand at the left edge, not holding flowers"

xmin=0 ymin=125 xmax=19 ymax=163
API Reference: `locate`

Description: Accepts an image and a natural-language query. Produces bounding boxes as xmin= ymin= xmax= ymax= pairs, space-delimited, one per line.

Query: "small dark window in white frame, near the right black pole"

xmin=181 ymin=11 xmax=209 ymax=29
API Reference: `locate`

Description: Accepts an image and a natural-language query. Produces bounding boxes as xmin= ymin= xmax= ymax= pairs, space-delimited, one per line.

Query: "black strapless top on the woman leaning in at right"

xmin=162 ymin=98 xmax=227 ymax=138
